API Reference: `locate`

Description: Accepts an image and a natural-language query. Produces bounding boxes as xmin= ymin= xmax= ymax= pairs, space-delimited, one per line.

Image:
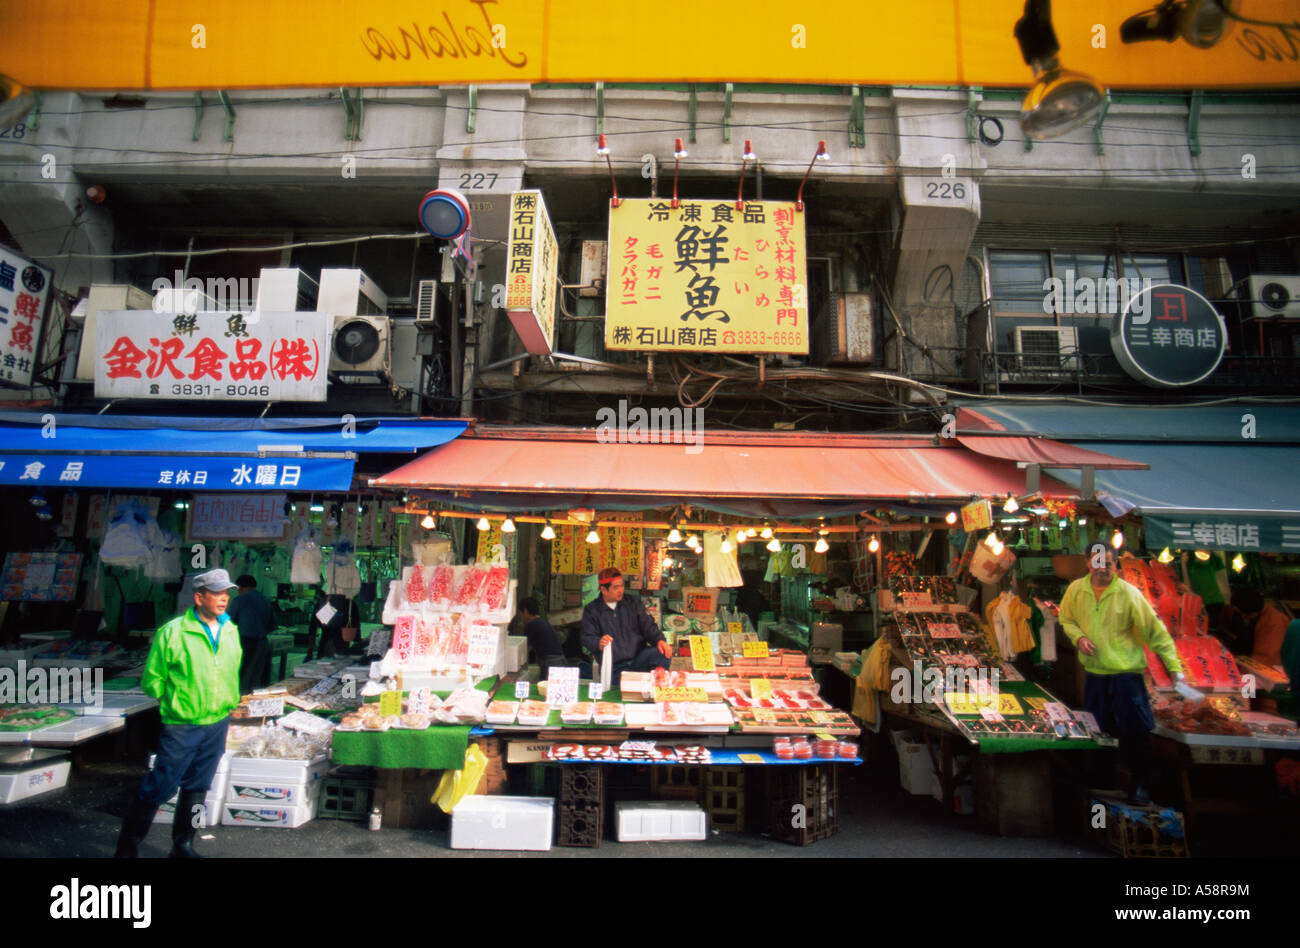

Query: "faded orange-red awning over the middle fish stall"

xmin=371 ymin=425 xmax=1073 ymax=502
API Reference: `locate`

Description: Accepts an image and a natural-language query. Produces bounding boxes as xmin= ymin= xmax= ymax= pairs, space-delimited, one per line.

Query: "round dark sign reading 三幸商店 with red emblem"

xmin=1110 ymin=283 xmax=1227 ymax=389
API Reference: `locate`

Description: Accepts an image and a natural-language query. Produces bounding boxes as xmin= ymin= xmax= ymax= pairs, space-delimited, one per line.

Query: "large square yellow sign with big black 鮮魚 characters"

xmin=605 ymin=198 xmax=809 ymax=352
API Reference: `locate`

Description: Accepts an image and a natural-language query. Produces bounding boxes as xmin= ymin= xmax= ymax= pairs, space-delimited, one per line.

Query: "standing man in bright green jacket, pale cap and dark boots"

xmin=117 ymin=570 xmax=243 ymax=858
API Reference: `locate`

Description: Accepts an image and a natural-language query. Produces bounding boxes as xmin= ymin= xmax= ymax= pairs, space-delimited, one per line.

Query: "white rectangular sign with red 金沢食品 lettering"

xmin=95 ymin=311 xmax=333 ymax=402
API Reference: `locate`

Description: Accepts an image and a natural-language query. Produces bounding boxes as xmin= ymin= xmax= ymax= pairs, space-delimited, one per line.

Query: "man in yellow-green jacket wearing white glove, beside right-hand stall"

xmin=1060 ymin=545 xmax=1183 ymax=806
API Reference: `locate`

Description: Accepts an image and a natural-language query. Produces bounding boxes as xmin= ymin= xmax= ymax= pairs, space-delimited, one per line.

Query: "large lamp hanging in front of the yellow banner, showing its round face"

xmin=1015 ymin=0 xmax=1106 ymax=142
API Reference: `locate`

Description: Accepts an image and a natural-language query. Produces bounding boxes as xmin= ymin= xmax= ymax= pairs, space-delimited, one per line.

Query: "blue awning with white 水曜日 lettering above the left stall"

xmin=0 ymin=412 xmax=468 ymax=492
